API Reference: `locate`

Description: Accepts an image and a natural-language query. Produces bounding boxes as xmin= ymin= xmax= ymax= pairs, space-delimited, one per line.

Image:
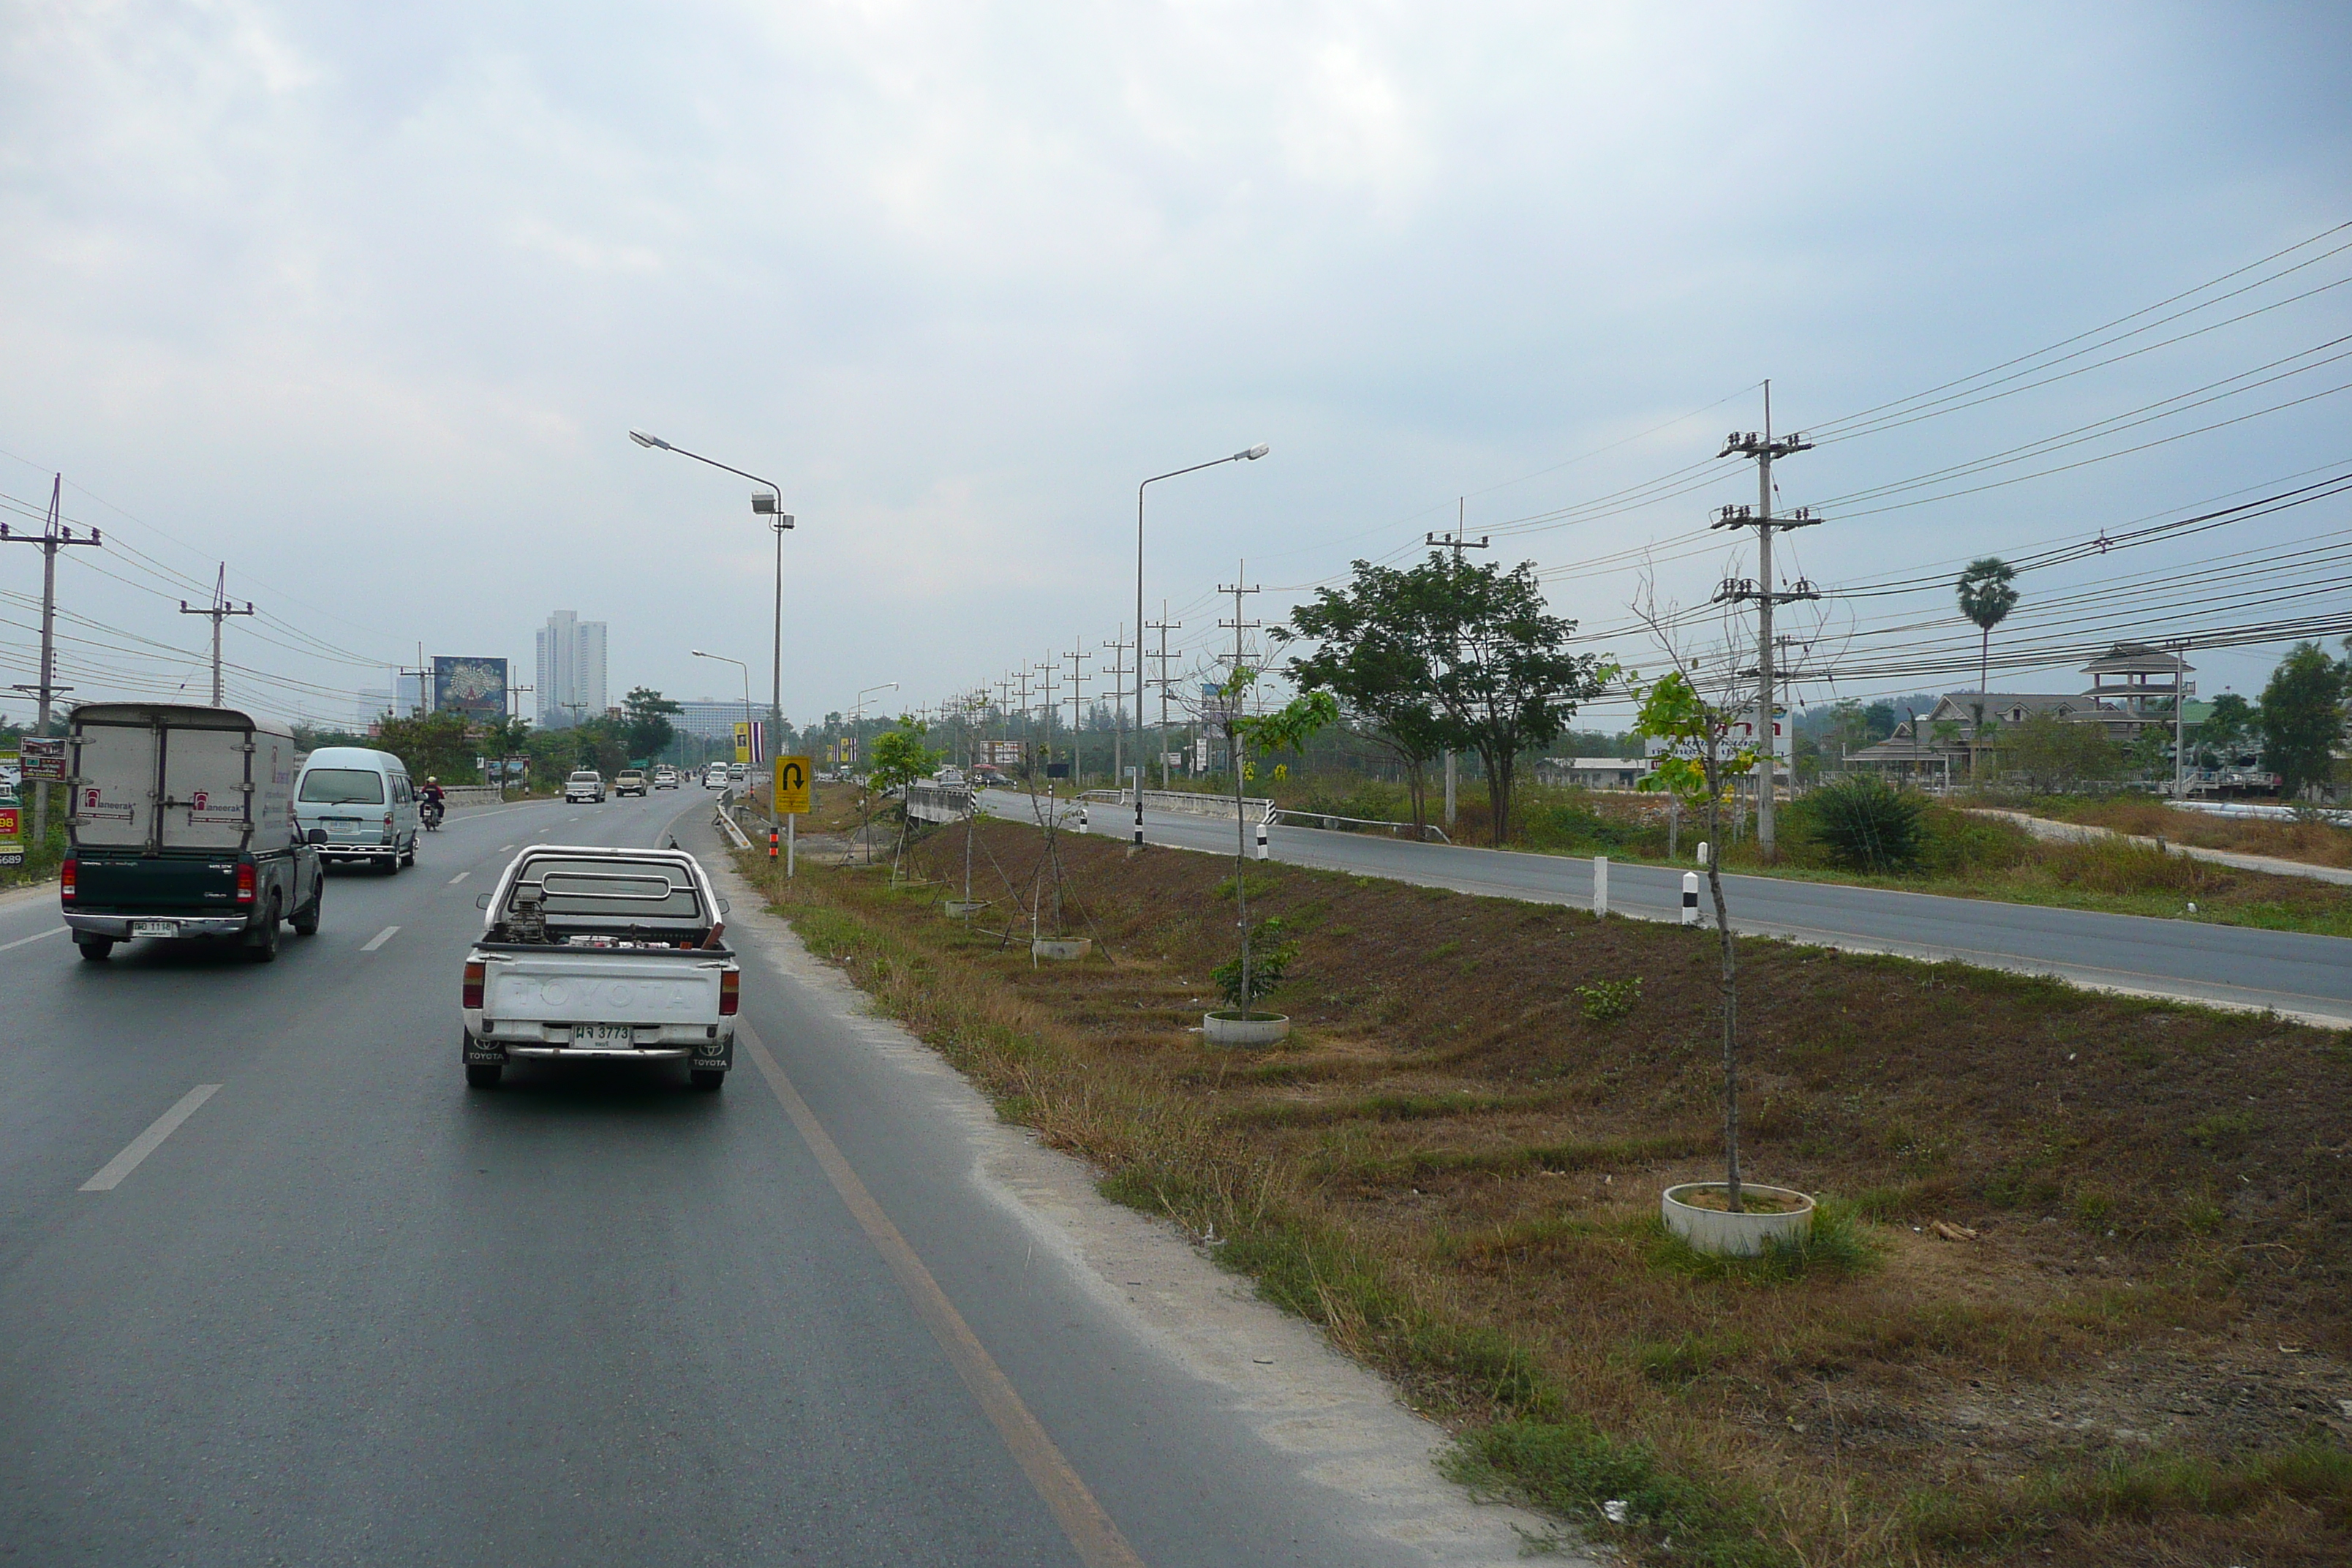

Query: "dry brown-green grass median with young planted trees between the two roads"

xmin=738 ymin=823 xmax=2352 ymax=1566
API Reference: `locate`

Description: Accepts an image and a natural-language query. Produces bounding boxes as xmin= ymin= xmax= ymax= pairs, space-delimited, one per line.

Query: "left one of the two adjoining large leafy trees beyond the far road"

xmin=1273 ymin=562 xmax=1447 ymax=830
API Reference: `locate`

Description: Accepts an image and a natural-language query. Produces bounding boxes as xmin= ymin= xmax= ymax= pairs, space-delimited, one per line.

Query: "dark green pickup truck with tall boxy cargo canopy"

xmin=59 ymin=703 xmax=327 ymax=964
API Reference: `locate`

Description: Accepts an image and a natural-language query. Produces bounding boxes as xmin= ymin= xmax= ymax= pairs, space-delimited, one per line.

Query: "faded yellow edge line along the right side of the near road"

xmin=736 ymin=1018 xmax=1143 ymax=1568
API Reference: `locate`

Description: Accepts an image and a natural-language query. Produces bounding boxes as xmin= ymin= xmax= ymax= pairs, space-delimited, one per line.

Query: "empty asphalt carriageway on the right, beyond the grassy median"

xmin=981 ymin=790 xmax=2352 ymax=1025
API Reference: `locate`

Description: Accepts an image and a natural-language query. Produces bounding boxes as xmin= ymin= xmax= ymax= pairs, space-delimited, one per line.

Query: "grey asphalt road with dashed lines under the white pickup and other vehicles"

xmin=0 ymin=790 xmax=1517 ymax=1568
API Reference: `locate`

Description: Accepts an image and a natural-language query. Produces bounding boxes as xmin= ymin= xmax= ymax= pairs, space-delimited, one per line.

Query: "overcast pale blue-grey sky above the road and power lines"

xmin=0 ymin=0 xmax=2352 ymax=724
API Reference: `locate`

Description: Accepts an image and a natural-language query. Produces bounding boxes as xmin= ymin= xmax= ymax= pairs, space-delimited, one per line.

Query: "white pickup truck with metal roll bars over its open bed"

xmin=459 ymin=844 xmax=743 ymax=1088
